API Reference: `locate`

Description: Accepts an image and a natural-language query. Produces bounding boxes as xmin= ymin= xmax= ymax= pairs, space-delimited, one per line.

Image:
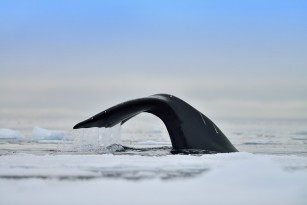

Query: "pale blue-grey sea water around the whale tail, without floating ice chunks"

xmin=0 ymin=114 xmax=307 ymax=156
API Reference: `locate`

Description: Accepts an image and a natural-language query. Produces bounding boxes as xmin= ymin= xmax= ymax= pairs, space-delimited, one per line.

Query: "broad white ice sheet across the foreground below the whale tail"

xmin=0 ymin=152 xmax=307 ymax=205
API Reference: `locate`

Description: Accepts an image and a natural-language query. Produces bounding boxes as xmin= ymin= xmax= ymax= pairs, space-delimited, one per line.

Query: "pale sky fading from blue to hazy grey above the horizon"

xmin=0 ymin=0 xmax=307 ymax=118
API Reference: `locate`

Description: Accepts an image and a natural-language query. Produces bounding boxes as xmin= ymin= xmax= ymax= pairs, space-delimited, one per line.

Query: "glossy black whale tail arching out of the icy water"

xmin=74 ymin=94 xmax=238 ymax=152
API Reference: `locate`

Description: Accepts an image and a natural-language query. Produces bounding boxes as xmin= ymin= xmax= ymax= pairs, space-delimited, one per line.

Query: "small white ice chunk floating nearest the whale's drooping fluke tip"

xmin=32 ymin=127 xmax=65 ymax=141
